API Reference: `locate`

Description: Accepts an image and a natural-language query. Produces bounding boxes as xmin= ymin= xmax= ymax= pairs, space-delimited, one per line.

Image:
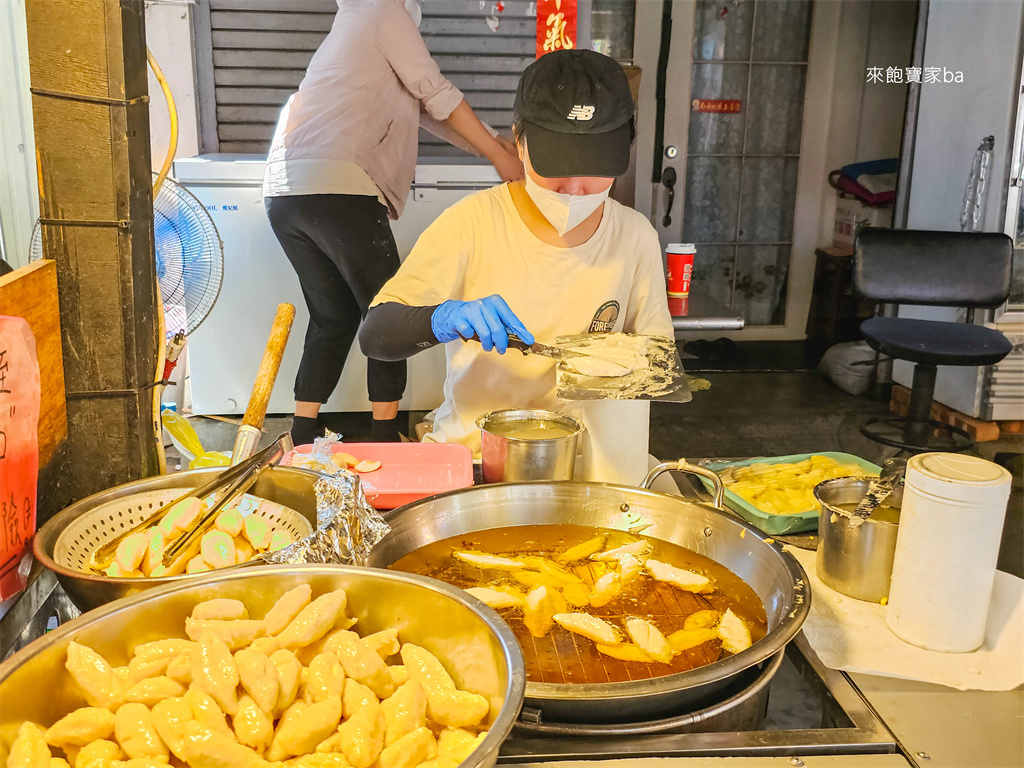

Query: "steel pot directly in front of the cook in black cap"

xmin=476 ymin=410 xmax=584 ymax=482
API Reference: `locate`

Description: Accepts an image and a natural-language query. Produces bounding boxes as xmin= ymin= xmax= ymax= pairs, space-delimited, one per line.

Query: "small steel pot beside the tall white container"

xmin=814 ymin=477 xmax=903 ymax=603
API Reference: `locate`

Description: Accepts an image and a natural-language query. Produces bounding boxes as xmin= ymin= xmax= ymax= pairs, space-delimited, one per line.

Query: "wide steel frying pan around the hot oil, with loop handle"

xmin=370 ymin=463 xmax=810 ymax=723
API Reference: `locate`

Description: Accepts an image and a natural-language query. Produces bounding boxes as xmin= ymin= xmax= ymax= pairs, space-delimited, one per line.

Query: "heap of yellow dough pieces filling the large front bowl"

xmin=7 ymin=585 xmax=490 ymax=768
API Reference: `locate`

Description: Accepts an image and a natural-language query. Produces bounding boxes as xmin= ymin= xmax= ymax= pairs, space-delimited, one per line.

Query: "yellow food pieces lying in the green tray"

xmin=718 ymin=456 xmax=864 ymax=515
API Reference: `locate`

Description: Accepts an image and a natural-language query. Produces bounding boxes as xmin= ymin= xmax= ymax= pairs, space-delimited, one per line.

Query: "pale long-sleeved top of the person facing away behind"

xmin=267 ymin=0 xmax=463 ymax=218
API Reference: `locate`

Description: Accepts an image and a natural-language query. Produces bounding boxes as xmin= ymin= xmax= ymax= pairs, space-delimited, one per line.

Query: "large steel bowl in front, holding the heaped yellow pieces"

xmin=0 ymin=565 xmax=525 ymax=768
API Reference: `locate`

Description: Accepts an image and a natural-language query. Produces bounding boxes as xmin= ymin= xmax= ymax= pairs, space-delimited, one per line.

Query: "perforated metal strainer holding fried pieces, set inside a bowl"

xmin=53 ymin=488 xmax=312 ymax=573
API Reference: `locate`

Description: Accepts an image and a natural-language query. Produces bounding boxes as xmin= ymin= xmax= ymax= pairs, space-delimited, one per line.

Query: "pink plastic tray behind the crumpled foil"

xmin=281 ymin=442 xmax=473 ymax=509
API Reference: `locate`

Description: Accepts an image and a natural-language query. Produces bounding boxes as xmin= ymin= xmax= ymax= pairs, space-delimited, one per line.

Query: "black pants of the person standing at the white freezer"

xmin=263 ymin=195 xmax=406 ymax=402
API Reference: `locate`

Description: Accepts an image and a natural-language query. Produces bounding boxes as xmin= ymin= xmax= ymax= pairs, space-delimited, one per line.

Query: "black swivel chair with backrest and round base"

xmin=854 ymin=228 xmax=1013 ymax=453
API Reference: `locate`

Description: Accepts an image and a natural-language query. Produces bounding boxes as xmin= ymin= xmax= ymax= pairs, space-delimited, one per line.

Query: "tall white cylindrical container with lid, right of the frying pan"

xmin=886 ymin=454 xmax=1010 ymax=652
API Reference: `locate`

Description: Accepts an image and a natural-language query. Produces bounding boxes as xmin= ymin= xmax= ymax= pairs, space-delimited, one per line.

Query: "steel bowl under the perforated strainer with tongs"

xmin=32 ymin=467 xmax=321 ymax=610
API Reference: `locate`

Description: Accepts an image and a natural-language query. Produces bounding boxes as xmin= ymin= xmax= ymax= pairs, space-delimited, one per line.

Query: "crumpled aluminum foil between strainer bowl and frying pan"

xmin=262 ymin=432 xmax=391 ymax=565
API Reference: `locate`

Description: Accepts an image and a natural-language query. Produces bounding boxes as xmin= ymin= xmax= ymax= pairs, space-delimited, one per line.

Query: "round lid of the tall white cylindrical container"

xmin=906 ymin=454 xmax=1010 ymax=503
